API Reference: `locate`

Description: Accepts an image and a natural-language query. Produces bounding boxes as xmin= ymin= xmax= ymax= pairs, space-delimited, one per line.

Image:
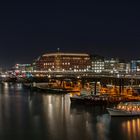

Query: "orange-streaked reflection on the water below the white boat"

xmin=110 ymin=117 xmax=140 ymax=140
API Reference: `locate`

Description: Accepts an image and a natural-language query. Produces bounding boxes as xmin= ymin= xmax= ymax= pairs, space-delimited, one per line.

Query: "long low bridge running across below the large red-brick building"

xmin=2 ymin=71 xmax=140 ymax=85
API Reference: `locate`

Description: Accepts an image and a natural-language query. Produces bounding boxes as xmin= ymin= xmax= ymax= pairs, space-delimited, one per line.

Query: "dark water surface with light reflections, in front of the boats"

xmin=0 ymin=84 xmax=140 ymax=140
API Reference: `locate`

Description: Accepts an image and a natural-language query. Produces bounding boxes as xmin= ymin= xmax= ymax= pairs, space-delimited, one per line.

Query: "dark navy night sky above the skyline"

xmin=0 ymin=0 xmax=140 ymax=67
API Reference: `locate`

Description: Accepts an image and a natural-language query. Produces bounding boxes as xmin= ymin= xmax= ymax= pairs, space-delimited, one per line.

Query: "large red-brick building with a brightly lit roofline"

xmin=34 ymin=52 xmax=91 ymax=72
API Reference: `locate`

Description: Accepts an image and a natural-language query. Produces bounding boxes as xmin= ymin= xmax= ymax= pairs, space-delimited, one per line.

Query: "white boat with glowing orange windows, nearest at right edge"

xmin=107 ymin=102 xmax=140 ymax=116
